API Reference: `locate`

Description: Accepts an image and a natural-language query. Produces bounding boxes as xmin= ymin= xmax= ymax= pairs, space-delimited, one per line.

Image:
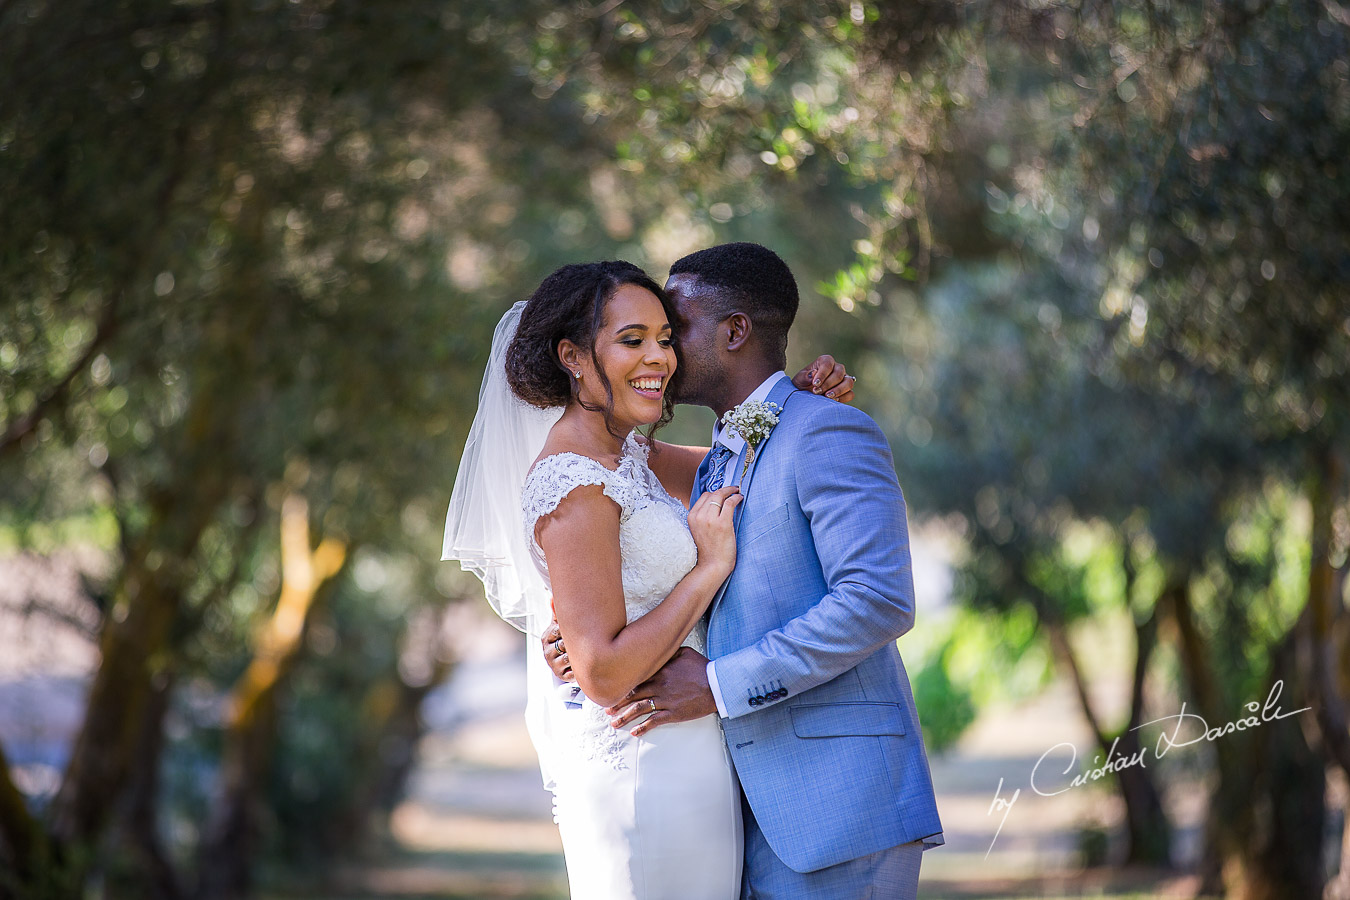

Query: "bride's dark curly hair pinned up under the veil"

xmin=506 ymin=260 xmax=680 ymax=437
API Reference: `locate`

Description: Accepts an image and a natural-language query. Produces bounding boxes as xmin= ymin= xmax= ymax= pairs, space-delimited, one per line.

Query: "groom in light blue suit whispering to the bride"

xmin=548 ymin=243 xmax=942 ymax=900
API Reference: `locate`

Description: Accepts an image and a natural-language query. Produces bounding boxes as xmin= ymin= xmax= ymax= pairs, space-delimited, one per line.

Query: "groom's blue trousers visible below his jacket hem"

xmin=741 ymin=795 xmax=923 ymax=900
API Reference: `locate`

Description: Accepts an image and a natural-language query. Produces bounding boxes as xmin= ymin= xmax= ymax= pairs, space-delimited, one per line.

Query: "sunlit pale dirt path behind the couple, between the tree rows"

xmin=340 ymin=612 xmax=1193 ymax=900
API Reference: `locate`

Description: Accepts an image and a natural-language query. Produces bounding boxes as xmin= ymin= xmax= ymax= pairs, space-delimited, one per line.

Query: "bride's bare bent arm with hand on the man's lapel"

xmin=535 ymin=484 xmax=740 ymax=706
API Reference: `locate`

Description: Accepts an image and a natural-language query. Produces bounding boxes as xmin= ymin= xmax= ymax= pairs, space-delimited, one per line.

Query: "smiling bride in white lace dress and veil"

xmin=443 ymin=262 xmax=847 ymax=900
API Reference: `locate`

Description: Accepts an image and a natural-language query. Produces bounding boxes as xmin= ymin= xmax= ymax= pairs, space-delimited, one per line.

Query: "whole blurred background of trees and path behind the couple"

xmin=0 ymin=0 xmax=1350 ymax=900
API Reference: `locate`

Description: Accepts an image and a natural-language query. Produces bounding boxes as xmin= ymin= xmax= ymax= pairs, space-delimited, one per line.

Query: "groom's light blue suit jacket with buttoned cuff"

xmin=694 ymin=379 xmax=942 ymax=872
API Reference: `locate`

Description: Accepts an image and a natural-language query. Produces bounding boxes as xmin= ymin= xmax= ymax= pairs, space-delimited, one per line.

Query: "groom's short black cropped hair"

xmin=671 ymin=242 xmax=799 ymax=360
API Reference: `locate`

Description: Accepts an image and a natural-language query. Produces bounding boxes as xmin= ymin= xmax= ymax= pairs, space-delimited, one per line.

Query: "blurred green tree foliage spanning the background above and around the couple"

xmin=0 ymin=0 xmax=1350 ymax=890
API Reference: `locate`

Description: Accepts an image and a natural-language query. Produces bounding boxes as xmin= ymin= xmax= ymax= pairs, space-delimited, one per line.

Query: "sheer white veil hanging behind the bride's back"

xmin=440 ymin=301 xmax=563 ymax=789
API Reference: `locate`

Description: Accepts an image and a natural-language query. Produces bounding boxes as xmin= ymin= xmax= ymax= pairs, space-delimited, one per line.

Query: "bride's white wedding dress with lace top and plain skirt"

xmin=521 ymin=434 xmax=741 ymax=900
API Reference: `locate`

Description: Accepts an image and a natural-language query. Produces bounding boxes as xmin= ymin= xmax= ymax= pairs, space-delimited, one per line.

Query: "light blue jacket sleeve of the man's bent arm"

xmin=714 ymin=403 xmax=914 ymax=718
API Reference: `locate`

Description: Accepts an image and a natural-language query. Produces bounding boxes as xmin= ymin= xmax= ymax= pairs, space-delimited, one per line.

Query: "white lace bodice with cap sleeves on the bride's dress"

xmin=521 ymin=434 xmax=707 ymax=768
